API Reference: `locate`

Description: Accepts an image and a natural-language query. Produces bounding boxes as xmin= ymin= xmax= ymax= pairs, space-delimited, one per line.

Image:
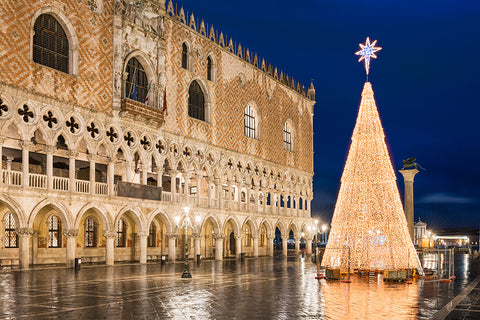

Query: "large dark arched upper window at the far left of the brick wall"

xmin=33 ymin=14 xmax=69 ymax=73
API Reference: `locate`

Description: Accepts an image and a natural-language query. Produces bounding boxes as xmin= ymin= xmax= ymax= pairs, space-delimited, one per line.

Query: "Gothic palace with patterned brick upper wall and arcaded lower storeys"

xmin=0 ymin=0 xmax=315 ymax=268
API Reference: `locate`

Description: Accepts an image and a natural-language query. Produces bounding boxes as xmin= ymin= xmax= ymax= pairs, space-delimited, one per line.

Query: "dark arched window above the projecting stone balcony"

xmin=125 ymin=58 xmax=149 ymax=103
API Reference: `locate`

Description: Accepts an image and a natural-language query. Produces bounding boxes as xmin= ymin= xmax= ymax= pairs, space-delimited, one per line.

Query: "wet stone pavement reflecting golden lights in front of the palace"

xmin=0 ymin=255 xmax=480 ymax=319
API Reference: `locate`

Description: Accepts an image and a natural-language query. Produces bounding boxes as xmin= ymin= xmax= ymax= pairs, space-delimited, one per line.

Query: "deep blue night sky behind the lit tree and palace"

xmin=177 ymin=0 xmax=480 ymax=229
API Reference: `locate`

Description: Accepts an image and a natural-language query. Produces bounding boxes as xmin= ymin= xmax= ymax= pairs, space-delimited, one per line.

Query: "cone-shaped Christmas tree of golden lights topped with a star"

xmin=322 ymin=38 xmax=419 ymax=270
